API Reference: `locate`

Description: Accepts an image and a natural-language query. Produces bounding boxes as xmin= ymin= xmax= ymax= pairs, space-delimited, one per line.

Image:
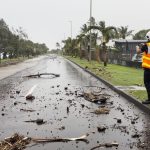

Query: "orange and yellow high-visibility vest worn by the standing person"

xmin=142 ymin=42 xmax=150 ymax=69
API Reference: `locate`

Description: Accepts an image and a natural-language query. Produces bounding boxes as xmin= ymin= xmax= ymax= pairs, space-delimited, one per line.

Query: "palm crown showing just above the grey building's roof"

xmin=117 ymin=26 xmax=133 ymax=39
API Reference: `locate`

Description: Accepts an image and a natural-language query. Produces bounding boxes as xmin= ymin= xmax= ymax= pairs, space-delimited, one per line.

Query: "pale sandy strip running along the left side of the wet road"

xmin=0 ymin=56 xmax=46 ymax=80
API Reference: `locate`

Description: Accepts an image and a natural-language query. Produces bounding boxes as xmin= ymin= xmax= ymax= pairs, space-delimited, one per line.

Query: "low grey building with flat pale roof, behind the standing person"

xmin=109 ymin=40 xmax=146 ymax=67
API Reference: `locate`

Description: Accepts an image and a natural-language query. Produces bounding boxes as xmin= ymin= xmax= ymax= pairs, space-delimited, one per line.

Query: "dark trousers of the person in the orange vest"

xmin=144 ymin=69 xmax=150 ymax=100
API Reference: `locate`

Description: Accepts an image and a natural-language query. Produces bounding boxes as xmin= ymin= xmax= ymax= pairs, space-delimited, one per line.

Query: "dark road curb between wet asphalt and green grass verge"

xmin=67 ymin=59 xmax=150 ymax=113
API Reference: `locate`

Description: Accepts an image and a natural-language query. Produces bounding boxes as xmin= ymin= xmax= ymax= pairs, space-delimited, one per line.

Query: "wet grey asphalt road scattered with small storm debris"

xmin=0 ymin=57 xmax=150 ymax=150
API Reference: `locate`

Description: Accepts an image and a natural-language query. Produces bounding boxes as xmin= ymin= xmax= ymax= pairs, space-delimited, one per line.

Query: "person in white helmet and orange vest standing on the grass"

xmin=136 ymin=31 xmax=150 ymax=104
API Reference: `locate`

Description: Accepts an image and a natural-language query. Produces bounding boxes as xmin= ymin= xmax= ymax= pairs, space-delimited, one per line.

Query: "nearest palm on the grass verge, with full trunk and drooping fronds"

xmin=89 ymin=21 xmax=116 ymax=66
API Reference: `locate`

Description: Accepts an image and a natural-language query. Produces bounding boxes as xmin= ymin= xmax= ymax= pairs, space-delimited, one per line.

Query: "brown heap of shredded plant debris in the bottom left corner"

xmin=0 ymin=133 xmax=31 ymax=150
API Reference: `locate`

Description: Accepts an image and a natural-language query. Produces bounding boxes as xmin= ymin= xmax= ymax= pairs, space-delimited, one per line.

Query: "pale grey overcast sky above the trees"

xmin=0 ymin=0 xmax=150 ymax=49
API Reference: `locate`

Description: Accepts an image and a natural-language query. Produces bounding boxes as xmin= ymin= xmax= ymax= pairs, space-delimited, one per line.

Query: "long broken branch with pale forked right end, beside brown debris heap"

xmin=32 ymin=135 xmax=88 ymax=143
